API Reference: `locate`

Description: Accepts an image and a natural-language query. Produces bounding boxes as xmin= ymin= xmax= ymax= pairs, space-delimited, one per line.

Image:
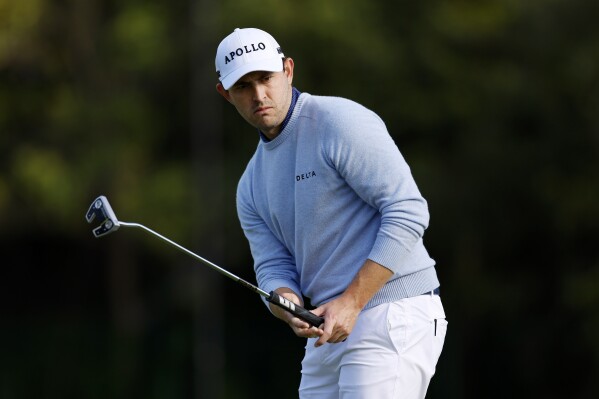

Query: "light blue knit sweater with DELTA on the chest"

xmin=237 ymin=93 xmax=439 ymax=309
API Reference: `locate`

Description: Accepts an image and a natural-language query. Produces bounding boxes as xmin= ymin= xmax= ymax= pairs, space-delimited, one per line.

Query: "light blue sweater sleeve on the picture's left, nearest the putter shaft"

xmin=237 ymin=167 xmax=302 ymax=302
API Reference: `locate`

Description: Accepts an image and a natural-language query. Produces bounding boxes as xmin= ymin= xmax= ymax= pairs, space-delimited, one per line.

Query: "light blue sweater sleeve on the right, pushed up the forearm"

xmin=325 ymin=104 xmax=429 ymax=275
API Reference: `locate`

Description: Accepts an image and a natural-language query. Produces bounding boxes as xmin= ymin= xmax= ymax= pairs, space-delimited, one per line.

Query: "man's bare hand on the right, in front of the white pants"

xmin=313 ymin=293 xmax=362 ymax=347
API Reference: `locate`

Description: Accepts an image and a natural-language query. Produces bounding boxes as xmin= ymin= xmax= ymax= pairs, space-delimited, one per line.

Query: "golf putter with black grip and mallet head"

xmin=85 ymin=195 xmax=324 ymax=327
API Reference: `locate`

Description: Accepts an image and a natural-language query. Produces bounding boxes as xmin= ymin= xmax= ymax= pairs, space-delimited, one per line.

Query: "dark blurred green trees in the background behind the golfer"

xmin=0 ymin=0 xmax=599 ymax=399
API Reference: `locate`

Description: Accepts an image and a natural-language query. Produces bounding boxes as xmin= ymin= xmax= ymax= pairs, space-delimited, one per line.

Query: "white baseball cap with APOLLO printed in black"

xmin=215 ymin=28 xmax=285 ymax=90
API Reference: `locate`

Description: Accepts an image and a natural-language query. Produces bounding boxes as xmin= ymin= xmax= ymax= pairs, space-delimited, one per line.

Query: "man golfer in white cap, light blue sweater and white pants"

xmin=216 ymin=28 xmax=447 ymax=399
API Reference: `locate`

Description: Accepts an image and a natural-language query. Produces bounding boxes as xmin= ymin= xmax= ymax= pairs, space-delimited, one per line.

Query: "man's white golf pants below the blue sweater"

xmin=299 ymin=295 xmax=447 ymax=399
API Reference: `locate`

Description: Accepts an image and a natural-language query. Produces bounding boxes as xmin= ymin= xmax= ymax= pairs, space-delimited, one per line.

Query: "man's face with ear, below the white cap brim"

xmin=216 ymin=58 xmax=293 ymax=139
